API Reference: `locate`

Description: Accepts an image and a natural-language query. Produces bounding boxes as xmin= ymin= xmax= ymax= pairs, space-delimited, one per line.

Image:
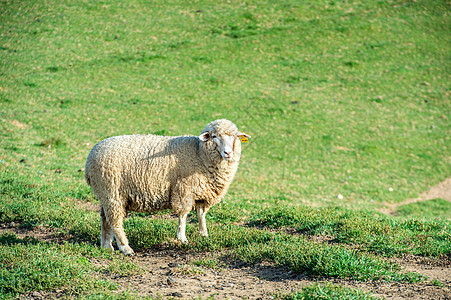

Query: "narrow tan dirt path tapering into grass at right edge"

xmin=379 ymin=178 xmax=451 ymax=215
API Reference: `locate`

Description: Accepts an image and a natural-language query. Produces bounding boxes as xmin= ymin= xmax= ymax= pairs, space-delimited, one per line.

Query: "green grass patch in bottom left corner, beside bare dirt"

xmin=0 ymin=233 xmax=148 ymax=299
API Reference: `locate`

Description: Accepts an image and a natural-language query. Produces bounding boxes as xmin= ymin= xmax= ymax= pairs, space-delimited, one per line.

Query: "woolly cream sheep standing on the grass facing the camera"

xmin=85 ymin=119 xmax=250 ymax=255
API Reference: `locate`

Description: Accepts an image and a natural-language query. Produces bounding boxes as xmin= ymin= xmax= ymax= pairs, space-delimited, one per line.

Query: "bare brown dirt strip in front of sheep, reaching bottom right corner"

xmin=107 ymin=251 xmax=451 ymax=299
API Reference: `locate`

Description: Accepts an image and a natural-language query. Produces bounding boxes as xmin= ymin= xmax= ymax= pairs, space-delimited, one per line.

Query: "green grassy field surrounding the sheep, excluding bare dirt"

xmin=0 ymin=0 xmax=451 ymax=299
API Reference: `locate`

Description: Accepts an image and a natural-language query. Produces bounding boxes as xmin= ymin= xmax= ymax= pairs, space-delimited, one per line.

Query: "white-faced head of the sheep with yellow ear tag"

xmin=199 ymin=119 xmax=250 ymax=161
